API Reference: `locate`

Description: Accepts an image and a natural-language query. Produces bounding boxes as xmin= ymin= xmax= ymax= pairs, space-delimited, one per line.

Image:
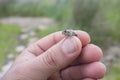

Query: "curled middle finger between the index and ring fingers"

xmin=72 ymin=44 xmax=103 ymax=65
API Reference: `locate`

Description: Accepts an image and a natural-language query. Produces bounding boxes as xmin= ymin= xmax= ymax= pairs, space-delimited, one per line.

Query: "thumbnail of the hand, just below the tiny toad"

xmin=62 ymin=37 xmax=77 ymax=54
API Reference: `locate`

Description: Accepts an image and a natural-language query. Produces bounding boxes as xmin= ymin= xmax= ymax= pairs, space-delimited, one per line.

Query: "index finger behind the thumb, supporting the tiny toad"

xmin=27 ymin=30 xmax=90 ymax=55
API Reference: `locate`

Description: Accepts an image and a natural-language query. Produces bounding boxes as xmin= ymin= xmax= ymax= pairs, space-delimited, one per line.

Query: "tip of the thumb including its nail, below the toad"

xmin=62 ymin=36 xmax=82 ymax=57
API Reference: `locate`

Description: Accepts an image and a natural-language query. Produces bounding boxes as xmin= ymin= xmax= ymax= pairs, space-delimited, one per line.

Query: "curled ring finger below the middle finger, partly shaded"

xmin=62 ymin=62 xmax=106 ymax=80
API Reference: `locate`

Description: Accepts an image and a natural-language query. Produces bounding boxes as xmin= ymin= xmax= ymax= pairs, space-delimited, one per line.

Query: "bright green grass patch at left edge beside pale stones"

xmin=0 ymin=24 xmax=21 ymax=67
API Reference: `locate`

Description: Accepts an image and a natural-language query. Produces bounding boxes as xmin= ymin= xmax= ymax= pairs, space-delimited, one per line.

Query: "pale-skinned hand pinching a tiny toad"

xmin=2 ymin=30 xmax=106 ymax=80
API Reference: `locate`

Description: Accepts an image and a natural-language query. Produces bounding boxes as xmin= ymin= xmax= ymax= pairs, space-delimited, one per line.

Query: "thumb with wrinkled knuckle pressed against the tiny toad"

xmin=33 ymin=36 xmax=82 ymax=76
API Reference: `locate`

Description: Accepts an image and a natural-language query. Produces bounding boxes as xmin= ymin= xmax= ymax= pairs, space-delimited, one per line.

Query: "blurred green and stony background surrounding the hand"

xmin=0 ymin=0 xmax=120 ymax=80
